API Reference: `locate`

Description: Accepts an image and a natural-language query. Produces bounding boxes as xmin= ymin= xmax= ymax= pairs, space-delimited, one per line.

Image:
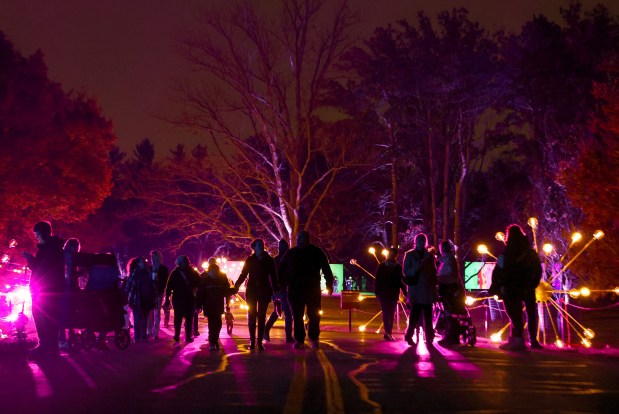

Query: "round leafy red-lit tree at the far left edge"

xmin=0 ymin=33 xmax=115 ymax=244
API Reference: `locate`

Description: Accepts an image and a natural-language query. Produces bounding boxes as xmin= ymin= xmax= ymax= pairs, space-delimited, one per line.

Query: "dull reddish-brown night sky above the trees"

xmin=0 ymin=0 xmax=619 ymax=155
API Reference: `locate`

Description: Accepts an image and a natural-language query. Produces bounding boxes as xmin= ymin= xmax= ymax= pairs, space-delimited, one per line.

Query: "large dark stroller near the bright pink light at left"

xmin=64 ymin=253 xmax=131 ymax=351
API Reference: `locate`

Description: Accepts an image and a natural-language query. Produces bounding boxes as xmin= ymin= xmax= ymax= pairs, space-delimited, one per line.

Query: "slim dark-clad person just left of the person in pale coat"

xmin=374 ymin=247 xmax=406 ymax=341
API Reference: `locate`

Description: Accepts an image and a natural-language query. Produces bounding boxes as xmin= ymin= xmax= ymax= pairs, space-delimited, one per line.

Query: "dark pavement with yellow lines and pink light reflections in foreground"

xmin=0 ymin=300 xmax=619 ymax=414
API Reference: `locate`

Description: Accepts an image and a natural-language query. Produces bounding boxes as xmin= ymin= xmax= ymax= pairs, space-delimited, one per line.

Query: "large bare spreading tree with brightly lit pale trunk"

xmin=145 ymin=0 xmax=359 ymax=249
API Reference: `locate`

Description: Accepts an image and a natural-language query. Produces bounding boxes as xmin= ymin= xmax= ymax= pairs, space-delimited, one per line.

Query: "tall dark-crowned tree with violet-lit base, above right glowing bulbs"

xmin=504 ymin=3 xmax=619 ymax=247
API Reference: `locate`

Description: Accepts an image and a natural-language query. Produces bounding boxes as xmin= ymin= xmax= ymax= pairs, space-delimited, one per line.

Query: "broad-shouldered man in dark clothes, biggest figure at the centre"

xmin=279 ymin=231 xmax=333 ymax=349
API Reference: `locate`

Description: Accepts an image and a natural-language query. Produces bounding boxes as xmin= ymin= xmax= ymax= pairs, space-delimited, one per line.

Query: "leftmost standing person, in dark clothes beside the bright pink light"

xmin=23 ymin=221 xmax=65 ymax=358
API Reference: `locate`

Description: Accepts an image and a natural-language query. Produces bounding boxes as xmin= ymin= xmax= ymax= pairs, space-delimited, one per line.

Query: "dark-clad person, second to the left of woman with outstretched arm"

xmin=164 ymin=256 xmax=200 ymax=342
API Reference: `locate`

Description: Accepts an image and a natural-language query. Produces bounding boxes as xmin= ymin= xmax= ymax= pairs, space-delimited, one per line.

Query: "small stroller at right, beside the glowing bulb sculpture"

xmin=435 ymin=284 xmax=477 ymax=346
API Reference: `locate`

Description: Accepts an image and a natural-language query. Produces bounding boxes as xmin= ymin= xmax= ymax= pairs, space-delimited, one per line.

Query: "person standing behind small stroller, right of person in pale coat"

xmin=437 ymin=240 xmax=466 ymax=346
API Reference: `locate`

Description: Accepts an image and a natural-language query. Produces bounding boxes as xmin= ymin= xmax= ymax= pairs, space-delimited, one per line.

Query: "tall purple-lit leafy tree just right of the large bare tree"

xmin=342 ymin=9 xmax=505 ymax=258
